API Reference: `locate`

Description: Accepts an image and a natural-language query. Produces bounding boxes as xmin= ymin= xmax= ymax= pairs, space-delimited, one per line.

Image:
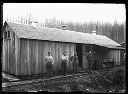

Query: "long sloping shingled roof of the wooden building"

xmin=5 ymin=22 xmax=121 ymax=48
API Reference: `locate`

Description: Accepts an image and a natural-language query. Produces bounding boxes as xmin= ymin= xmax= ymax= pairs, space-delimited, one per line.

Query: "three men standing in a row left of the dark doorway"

xmin=45 ymin=52 xmax=78 ymax=76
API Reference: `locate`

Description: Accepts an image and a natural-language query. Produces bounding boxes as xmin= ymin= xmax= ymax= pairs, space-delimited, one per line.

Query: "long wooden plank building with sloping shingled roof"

xmin=2 ymin=22 xmax=121 ymax=75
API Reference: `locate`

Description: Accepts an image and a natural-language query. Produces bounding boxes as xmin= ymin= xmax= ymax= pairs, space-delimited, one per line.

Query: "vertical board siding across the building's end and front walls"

xmin=3 ymin=34 xmax=120 ymax=75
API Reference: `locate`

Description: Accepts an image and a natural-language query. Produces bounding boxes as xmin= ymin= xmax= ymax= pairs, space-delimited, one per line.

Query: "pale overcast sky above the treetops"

xmin=3 ymin=3 xmax=126 ymax=23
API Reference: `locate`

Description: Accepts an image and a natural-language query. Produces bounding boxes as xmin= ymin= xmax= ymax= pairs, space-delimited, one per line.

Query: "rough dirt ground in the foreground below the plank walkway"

xmin=3 ymin=67 xmax=126 ymax=93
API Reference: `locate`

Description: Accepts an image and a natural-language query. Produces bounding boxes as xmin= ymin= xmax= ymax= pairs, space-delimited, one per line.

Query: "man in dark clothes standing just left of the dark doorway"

xmin=72 ymin=52 xmax=79 ymax=74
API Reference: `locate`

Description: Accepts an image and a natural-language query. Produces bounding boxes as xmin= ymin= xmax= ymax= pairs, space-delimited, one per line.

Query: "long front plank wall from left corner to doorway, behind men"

xmin=17 ymin=39 xmax=75 ymax=75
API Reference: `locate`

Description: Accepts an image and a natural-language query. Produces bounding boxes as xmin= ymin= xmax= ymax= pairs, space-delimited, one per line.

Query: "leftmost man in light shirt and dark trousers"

xmin=45 ymin=52 xmax=54 ymax=76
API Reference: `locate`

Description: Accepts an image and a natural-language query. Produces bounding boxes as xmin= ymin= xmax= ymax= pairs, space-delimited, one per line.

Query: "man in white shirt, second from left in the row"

xmin=61 ymin=52 xmax=68 ymax=75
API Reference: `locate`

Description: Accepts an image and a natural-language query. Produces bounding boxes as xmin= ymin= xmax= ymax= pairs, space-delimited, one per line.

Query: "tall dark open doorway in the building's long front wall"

xmin=76 ymin=43 xmax=83 ymax=68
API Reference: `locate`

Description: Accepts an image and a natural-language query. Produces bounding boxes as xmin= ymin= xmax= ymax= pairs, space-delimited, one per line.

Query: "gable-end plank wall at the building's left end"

xmin=3 ymin=25 xmax=20 ymax=75
